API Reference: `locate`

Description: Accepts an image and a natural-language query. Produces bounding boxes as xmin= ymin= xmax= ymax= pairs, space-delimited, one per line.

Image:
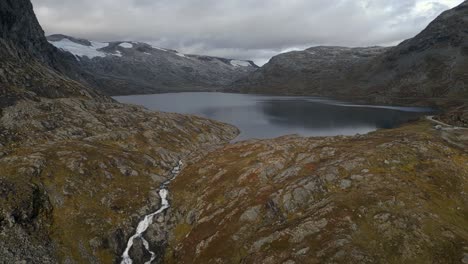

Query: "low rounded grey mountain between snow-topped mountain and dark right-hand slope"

xmin=232 ymin=46 xmax=388 ymax=97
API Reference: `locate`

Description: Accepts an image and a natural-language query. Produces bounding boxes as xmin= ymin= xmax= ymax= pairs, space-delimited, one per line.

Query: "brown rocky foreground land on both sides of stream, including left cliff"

xmin=0 ymin=0 xmax=468 ymax=264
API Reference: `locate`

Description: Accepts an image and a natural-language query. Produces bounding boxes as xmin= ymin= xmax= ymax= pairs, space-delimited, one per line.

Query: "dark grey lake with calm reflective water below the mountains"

xmin=114 ymin=93 xmax=432 ymax=140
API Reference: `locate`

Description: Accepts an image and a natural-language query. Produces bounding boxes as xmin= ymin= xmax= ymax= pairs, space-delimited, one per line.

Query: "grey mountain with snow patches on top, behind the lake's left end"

xmin=48 ymin=35 xmax=258 ymax=95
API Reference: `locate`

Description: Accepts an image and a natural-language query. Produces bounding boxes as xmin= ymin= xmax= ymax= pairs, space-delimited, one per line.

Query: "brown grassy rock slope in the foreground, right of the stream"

xmin=166 ymin=121 xmax=468 ymax=263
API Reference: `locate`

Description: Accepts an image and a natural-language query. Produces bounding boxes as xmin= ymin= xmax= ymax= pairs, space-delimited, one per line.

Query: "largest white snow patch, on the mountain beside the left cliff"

xmin=49 ymin=39 xmax=109 ymax=60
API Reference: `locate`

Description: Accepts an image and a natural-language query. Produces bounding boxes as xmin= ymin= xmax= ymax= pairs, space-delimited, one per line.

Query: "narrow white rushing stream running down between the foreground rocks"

xmin=120 ymin=160 xmax=183 ymax=264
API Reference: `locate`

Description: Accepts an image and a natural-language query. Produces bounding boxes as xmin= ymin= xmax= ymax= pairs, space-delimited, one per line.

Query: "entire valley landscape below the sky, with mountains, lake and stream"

xmin=0 ymin=0 xmax=468 ymax=264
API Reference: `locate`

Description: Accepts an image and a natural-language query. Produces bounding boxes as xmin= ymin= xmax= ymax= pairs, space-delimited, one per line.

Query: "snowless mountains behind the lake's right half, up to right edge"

xmin=232 ymin=1 xmax=468 ymax=104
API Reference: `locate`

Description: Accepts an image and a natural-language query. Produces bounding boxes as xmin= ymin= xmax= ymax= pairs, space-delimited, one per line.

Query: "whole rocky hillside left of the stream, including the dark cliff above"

xmin=0 ymin=0 xmax=238 ymax=263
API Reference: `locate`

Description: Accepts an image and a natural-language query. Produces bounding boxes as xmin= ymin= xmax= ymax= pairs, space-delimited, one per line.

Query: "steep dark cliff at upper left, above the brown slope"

xmin=0 ymin=0 xmax=104 ymax=107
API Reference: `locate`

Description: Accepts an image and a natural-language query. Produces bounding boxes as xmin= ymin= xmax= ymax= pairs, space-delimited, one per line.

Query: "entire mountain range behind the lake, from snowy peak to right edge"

xmin=35 ymin=1 xmax=468 ymax=106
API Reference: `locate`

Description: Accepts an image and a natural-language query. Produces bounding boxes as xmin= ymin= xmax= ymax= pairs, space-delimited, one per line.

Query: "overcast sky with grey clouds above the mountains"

xmin=32 ymin=0 xmax=463 ymax=64
